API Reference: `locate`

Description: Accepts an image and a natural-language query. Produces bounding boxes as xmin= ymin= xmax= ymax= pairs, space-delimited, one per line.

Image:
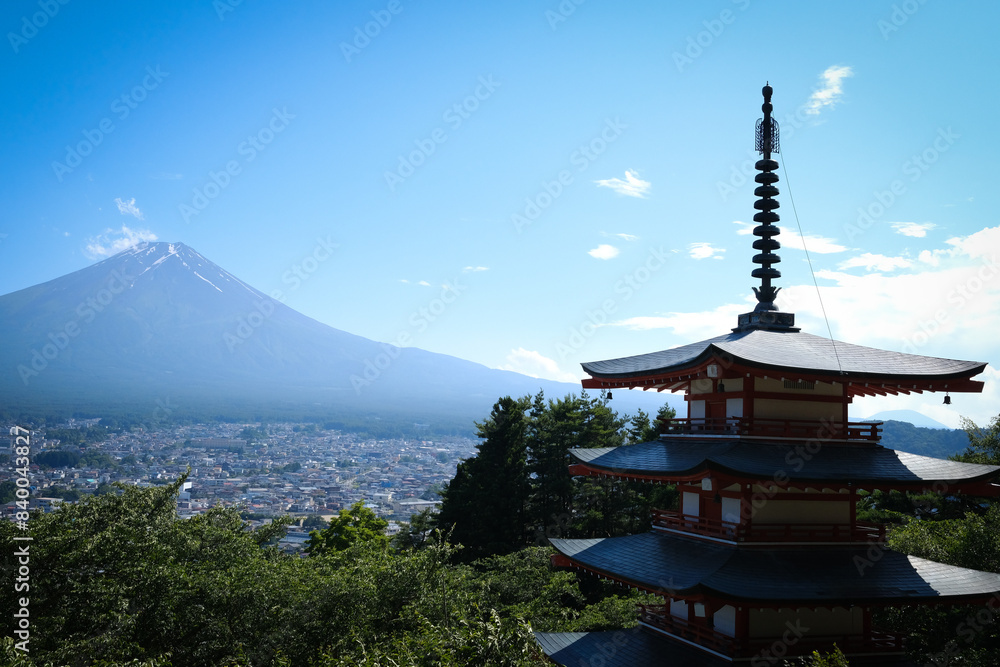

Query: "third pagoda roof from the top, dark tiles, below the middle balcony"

xmin=551 ymin=531 xmax=1000 ymax=606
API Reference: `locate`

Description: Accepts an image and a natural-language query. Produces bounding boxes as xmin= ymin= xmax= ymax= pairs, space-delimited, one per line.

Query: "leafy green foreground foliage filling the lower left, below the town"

xmin=0 ymin=464 xmax=656 ymax=667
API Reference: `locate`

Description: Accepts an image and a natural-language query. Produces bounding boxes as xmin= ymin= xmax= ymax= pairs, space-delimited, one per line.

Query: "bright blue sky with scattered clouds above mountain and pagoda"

xmin=0 ymin=0 xmax=1000 ymax=425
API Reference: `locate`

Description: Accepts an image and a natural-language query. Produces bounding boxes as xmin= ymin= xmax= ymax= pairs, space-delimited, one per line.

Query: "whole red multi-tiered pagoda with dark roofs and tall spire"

xmin=536 ymin=86 xmax=1000 ymax=667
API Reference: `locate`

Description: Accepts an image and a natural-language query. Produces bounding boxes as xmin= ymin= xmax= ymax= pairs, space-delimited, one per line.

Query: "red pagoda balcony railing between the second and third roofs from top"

xmin=652 ymin=509 xmax=886 ymax=544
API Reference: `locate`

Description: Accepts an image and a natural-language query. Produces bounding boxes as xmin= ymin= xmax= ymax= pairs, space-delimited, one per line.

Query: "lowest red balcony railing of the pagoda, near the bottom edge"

xmin=639 ymin=605 xmax=904 ymax=659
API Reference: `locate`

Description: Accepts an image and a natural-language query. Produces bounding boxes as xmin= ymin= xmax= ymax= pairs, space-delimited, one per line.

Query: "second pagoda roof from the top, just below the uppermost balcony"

xmin=570 ymin=437 xmax=1000 ymax=490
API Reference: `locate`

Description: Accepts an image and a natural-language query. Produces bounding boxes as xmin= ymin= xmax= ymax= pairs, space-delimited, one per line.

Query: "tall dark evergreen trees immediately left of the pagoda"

xmin=438 ymin=392 xmax=677 ymax=559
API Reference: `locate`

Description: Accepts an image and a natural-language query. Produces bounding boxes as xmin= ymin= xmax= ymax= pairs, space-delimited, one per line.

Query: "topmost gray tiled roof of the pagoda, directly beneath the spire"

xmin=582 ymin=330 xmax=986 ymax=379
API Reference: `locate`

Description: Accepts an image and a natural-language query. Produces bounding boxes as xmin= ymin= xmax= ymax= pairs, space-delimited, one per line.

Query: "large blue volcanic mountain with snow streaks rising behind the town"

xmin=0 ymin=242 xmax=682 ymax=431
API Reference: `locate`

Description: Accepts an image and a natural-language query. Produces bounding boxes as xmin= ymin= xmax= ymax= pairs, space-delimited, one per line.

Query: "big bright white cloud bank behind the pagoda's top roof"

xmin=600 ymin=226 xmax=1000 ymax=426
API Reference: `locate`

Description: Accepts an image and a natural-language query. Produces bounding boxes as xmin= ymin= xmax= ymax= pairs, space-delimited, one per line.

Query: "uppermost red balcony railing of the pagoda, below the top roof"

xmin=660 ymin=417 xmax=882 ymax=442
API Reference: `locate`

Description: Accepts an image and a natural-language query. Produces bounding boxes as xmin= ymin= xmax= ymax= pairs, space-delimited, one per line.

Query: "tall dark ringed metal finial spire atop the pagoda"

xmin=734 ymin=84 xmax=798 ymax=331
